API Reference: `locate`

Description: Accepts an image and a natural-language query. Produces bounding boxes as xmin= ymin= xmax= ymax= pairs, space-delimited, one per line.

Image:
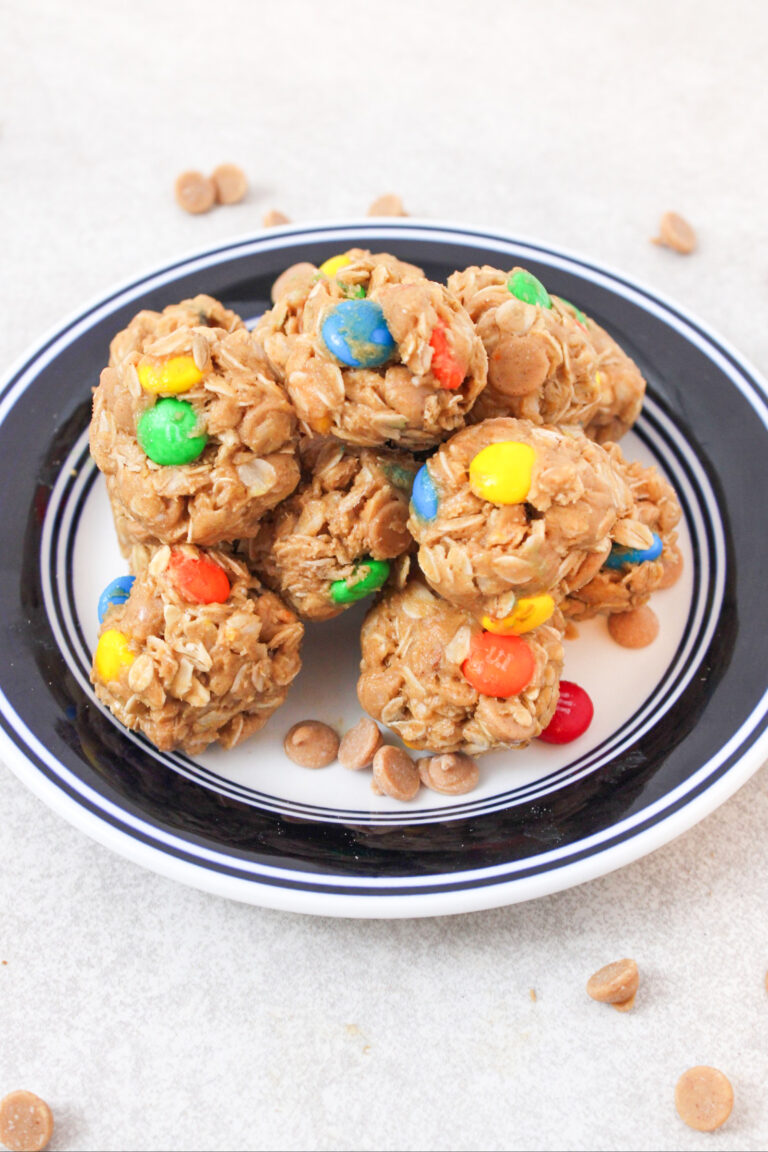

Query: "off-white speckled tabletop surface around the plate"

xmin=0 ymin=0 xmax=768 ymax=1150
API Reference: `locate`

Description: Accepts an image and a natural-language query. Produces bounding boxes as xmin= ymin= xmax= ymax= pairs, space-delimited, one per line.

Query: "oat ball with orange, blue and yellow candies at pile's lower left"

xmin=91 ymin=545 xmax=304 ymax=755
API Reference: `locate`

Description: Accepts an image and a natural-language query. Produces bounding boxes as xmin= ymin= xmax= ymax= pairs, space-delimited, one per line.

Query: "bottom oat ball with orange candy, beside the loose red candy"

xmin=357 ymin=578 xmax=563 ymax=755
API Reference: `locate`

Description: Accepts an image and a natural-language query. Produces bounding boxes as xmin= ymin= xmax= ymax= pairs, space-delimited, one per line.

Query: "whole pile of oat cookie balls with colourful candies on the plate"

xmin=91 ymin=249 xmax=680 ymax=798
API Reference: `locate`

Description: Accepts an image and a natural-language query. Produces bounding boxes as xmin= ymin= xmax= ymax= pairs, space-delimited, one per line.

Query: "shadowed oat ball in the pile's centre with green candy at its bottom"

xmin=243 ymin=439 xmax=418 ymax=620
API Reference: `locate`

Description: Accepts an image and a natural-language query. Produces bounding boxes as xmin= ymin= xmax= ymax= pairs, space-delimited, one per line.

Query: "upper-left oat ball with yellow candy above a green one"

xmin=91 ymin=296 xmax=299 ymax=550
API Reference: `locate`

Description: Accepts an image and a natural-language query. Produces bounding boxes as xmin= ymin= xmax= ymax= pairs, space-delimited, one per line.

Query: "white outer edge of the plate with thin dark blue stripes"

xmin=0 ymin=218 xmax=768 ymax=918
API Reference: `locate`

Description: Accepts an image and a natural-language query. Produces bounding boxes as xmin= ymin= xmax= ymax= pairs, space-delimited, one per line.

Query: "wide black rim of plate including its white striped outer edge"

xmin=0 ymin=221 xmax=768 ymax=916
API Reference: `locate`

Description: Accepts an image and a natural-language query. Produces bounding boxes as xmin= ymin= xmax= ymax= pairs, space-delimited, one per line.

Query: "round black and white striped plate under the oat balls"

xmin=0 ymin=220 xmax=768 ymax=917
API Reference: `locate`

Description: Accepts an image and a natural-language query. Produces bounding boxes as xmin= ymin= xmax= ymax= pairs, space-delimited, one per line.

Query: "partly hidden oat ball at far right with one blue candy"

xmin=562 ymin=444 xmax=682 ymax=620
